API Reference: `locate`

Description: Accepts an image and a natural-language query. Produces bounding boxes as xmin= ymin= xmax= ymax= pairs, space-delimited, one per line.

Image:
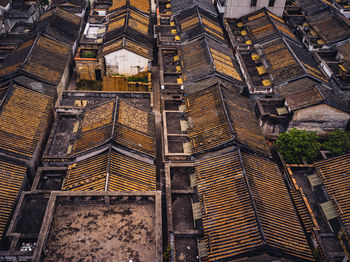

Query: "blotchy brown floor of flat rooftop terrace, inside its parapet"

xmin=44 ymin=201 xmax=156 ymax=261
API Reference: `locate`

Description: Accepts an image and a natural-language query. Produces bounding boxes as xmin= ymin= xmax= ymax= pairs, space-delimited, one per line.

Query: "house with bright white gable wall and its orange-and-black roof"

xmin=102 ymin=9 xmax=153 ymax=76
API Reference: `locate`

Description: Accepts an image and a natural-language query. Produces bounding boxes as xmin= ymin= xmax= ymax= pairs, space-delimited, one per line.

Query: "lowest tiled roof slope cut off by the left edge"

xmin=0 ymin=160 xmax=26 ymax=240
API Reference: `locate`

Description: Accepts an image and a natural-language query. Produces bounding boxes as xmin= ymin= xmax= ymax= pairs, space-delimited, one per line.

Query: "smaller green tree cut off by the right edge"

xmin=322 ymin=130 xmax=350 ymax=155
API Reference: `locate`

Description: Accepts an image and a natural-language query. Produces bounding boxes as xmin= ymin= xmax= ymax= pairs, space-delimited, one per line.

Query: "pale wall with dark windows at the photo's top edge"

xmin=224 ymin=0 xmax=286 ymax=18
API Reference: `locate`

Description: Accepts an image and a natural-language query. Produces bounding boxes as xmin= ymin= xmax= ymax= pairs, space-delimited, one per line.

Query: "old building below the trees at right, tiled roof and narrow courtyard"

xmin=286 ymin=153 xmax=349 ymax=261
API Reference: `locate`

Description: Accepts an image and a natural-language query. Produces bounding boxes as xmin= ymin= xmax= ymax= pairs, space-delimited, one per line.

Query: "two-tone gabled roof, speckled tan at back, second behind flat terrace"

xmin=72 ymin=100 xmax=156 ymax=157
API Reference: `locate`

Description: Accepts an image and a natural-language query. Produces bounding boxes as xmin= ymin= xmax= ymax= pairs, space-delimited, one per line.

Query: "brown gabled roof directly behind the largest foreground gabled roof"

xmin=185 ymin=84 xmax=270 ymax=156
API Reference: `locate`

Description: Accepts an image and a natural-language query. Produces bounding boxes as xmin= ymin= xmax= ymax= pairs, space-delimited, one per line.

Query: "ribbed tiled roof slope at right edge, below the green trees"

xmin=314 ymin=153 xmax=350 ymax=226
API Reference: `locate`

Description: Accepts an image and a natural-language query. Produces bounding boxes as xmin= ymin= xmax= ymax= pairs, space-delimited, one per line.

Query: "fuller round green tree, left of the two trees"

xmin=276 ymin=128 xmax=321 ymax=164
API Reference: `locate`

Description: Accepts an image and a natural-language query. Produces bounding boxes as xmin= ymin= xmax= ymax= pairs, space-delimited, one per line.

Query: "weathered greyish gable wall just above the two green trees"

xmin=288 ymin=104 xmax=350 ymax=133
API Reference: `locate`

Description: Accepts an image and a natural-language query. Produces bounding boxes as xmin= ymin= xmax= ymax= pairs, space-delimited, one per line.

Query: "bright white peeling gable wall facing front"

xmin=105 ymin=49 xmax=149 ymax=76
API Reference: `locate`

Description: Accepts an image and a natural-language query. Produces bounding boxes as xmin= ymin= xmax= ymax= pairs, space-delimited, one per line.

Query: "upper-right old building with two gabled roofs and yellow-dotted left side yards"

xmin=225 ymin=9 xmax=329 ymax=94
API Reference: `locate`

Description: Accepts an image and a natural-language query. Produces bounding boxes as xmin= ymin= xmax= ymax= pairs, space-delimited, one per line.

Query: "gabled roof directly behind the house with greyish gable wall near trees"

xmin=259 ymin=38 xmax=328 ymax=85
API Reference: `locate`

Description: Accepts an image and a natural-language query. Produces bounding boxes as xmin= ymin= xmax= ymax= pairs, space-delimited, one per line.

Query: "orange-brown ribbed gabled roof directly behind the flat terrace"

xmin=62 ymin=148 xmax=156 ymax=191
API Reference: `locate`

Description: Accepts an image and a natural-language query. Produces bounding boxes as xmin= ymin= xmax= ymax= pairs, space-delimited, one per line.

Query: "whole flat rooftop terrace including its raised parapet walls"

xmin=34 ymin=192 xmax=161 ymax=262
